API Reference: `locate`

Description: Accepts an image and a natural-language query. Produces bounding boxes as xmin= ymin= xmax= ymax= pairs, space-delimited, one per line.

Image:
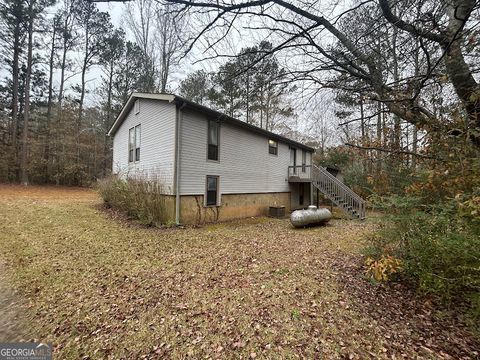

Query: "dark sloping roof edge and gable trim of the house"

xmin=108 ymin=93 xmax=315 ymax=152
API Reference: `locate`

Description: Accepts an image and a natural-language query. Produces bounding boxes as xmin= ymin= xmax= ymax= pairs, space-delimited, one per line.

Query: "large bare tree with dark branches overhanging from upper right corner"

xmin=165 ymin=0 xmax=480 ymax=146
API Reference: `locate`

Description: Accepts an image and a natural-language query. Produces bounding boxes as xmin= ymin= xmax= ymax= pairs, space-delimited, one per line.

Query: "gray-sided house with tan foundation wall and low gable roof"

xmin=108 ymin=93 xmax=364 ymax=224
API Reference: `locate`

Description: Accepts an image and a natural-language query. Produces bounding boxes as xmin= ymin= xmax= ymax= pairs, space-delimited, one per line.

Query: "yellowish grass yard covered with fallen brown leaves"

xmin=0 ymin=185 xmax=479 ymax=359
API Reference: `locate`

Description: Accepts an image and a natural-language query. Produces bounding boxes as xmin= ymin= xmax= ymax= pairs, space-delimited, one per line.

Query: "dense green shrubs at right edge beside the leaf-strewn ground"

xmin=366 ymin=196 xmax=480 ymax=324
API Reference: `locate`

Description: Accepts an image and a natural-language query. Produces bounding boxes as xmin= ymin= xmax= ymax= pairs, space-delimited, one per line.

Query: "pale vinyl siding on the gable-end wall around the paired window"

xmin=112 ymin=99 xmax=176 ymax=194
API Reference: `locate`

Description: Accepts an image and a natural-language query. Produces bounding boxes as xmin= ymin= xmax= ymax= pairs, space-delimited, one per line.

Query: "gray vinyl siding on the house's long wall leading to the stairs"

xmin=180 ymin=110 xmax=311 ymax=195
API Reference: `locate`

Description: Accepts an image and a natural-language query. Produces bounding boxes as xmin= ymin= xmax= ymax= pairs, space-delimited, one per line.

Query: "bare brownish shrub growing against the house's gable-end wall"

xmin=98 ymin=176 xmax=167 ymax=226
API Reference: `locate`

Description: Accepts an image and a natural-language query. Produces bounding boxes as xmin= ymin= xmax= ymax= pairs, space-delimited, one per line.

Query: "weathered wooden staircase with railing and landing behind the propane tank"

xmin=289 ymin=165 xmax=366 ymax=219
